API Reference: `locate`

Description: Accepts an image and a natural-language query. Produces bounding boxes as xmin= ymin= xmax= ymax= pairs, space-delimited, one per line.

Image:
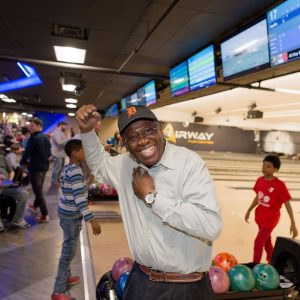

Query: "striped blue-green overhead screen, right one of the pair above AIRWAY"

xmin=187 ymin=45 xmax=217 ymax=92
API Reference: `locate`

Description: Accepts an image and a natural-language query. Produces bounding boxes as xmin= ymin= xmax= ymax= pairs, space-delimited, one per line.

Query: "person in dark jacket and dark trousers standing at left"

xmin=20 ymin=118 xmax=51 ymax=223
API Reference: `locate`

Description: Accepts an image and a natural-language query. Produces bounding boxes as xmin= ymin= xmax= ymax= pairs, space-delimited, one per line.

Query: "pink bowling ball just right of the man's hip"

xmin=208 ymin=266 xmax=230 ymax=294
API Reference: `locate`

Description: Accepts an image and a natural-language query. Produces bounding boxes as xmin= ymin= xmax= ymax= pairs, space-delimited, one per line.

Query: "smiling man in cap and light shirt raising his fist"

xmin=77 ymin=105 xmax=222 ymax=300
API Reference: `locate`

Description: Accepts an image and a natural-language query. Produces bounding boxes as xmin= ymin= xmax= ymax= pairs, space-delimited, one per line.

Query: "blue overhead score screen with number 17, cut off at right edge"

xmin=267 ymin=0 xmax=300 ymax=66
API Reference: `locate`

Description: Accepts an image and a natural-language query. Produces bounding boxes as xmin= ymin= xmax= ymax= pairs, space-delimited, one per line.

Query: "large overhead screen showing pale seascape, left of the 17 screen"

xmin=221 ymin=19 xmax=270 ymax=80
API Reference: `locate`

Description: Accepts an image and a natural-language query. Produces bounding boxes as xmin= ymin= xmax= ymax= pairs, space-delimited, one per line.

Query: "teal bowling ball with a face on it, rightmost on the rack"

xmin=252 ymin=264 xmax=280 ymax=290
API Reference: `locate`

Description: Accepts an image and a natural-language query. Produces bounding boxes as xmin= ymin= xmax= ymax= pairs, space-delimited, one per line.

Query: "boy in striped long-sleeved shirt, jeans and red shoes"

xmin=51 ymin=139 xmax=101 ymax=300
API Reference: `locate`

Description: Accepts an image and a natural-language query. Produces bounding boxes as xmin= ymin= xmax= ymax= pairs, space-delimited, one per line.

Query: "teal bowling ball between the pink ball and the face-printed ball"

xmin=228 ymin=265 xmax=255 ymax=292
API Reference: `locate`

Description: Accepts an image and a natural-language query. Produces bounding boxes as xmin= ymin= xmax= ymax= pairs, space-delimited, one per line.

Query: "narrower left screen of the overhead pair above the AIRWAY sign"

xmin=170 ymin=61 xmax=190 ymax=97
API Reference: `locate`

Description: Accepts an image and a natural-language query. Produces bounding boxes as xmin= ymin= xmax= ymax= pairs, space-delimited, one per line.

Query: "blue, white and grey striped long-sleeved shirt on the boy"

xmin=57 ymin=164 xmax=94 ymax=222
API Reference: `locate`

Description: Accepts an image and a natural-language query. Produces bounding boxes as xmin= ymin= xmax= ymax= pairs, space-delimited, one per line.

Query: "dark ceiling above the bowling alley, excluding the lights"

xmin=0 ymin=0 xmax=282 ymax=112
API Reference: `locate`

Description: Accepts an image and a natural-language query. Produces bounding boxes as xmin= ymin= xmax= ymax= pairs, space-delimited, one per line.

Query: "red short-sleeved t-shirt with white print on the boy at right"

xmin=253 ymin=176 xmax=291 ymax=228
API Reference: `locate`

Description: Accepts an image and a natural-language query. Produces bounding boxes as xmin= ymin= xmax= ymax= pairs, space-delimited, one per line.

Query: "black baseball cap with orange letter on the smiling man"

xmin=118 ymin=105 xmax=158 ymax=133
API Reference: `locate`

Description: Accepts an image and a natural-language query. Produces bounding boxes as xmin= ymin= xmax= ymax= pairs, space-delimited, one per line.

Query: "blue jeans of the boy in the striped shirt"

xmin=54 ymin=214 xmax=82 ymax=293
